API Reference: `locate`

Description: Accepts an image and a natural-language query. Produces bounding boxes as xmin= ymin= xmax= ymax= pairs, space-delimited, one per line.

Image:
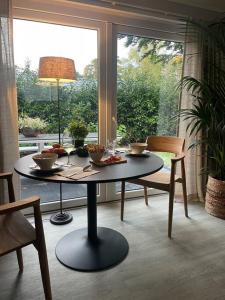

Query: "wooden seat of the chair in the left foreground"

xmin=0 ymin=211 xmax=36 ymax=256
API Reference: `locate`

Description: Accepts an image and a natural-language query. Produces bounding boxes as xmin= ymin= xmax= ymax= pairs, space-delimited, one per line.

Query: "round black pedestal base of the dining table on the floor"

xmin=55 ymin=227 xmax=129 ymax=271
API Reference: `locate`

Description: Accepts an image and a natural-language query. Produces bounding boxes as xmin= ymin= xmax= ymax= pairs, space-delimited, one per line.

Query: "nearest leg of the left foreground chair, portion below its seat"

xmin=36 ymin=241 xmax=52 ymax=300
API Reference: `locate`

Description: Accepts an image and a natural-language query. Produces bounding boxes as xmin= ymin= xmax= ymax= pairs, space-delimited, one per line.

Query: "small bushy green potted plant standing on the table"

xmin=68 ymin=120 xmax=88 ymax=148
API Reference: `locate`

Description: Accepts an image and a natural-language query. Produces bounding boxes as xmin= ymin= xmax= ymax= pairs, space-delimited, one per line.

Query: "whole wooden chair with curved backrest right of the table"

xmin=121 ymin=136 xmax=188 ymax=238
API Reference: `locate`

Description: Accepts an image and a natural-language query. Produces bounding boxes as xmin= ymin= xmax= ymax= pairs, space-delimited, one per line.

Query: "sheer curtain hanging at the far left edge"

xmin=0 ymin=0 xmax=19 ymax=203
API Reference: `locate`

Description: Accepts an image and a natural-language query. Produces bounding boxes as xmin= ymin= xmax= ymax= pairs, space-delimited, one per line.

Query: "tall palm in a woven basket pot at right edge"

xmin=179 ymin=19 xmax=225 ymax=219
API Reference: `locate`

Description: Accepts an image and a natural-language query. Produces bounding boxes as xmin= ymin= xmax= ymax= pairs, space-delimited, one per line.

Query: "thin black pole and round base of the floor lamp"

xmin=50 ymin=79 xmax=73 ymax=225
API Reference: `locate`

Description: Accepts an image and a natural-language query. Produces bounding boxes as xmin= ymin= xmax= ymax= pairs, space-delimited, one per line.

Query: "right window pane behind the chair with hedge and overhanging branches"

xmin=117 ymin=34 xmax=183 ymax=191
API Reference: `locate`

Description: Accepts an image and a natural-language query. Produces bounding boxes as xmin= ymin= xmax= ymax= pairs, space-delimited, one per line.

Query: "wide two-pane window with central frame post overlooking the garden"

xmin=14 ymin=12 xmax=183 ymax=204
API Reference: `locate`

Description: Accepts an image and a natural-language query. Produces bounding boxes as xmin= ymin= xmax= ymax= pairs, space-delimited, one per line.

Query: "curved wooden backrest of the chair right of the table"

xmin=146 ymin=135 xmax=185 ymax=155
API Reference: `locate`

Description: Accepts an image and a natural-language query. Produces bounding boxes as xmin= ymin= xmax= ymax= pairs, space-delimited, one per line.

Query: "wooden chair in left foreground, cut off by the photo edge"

xmin=0 ymin=173 xmax=52 ymax=300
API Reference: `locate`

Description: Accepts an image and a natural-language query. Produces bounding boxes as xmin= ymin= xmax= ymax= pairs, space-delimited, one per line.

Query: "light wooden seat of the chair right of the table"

xmin=129 ymin=172 xmax=180 ymax=187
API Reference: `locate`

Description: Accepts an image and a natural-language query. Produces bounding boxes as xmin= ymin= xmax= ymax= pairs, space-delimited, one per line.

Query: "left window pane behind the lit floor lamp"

xmin=14 ymin=19 xmax=98 ymax=202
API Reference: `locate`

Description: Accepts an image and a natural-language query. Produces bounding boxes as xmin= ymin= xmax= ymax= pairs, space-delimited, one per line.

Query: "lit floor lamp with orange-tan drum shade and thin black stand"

xmin=38 ymin=56 xmax=76 ymax=225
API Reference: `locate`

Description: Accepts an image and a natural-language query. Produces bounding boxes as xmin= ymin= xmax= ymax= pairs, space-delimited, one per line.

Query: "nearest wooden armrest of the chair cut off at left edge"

xmin=0 ymin=196 xmax=40 ymax=215
